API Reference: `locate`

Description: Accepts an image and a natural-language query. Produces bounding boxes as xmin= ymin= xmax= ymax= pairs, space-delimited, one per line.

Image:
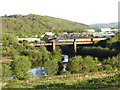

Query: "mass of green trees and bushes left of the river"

xmin=3 ymin=34 xmax=63 ymax=80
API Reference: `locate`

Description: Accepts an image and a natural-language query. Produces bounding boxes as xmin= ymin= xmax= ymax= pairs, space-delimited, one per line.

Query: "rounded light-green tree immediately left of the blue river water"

xmin=12 ymin=56 xmax=31 ymax=80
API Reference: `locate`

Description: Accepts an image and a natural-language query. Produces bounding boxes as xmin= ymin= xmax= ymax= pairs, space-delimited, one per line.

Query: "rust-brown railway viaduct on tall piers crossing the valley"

xmin=30 ymin=38 xmax=107 ymax=53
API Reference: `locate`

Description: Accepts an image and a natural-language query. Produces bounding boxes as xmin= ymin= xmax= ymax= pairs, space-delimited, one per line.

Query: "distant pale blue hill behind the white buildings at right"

xmin=90 ymin=22 xmax=118 ymax=28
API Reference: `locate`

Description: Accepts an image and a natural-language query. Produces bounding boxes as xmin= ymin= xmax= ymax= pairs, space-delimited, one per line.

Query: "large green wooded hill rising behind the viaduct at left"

xmin=2 ymin=14 xmax=91 ymax=35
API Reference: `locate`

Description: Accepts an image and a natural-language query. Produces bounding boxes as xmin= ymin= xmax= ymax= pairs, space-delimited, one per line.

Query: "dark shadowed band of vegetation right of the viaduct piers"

xmin=77 ymin=47 xmax=119 ymax=61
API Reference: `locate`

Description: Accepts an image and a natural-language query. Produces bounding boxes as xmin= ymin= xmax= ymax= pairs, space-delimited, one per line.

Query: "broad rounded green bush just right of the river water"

xmin=68 ymin=56 xmax=98 ymax=73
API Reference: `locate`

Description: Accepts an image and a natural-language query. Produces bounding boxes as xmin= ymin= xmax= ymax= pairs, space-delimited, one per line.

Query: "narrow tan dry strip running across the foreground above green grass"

xmin=20 ymin=71 xmax=120 ymax=82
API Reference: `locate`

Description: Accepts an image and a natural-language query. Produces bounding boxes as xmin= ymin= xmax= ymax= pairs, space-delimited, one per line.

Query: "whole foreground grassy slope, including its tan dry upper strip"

xmin=3 ymin=72 xmax=120 ymax=90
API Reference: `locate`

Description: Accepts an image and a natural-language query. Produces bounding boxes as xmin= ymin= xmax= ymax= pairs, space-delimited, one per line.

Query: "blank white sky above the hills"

xmin=0 ymin=0 xmax=120 ymax=25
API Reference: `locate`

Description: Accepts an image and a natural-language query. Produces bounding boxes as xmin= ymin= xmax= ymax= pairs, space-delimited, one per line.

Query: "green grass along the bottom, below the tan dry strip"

xmin=4 ymin=71 xmax=120 ymax=90
